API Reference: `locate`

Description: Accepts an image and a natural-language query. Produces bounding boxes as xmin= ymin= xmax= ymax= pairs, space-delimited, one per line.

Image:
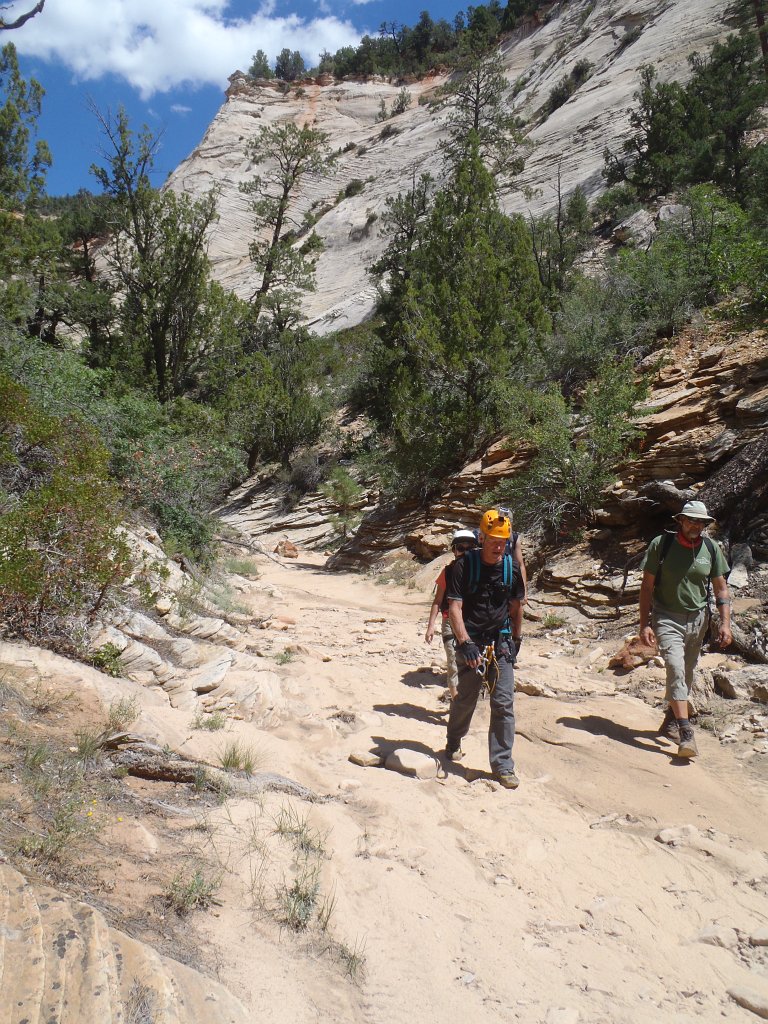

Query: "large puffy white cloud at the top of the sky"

xmin=13 ymin=0 xmax=360 ymax=99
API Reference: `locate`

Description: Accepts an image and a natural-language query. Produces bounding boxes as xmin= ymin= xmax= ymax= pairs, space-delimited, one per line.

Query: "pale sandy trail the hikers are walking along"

xmin=193 ymin=556 xmax=768 ymax=1024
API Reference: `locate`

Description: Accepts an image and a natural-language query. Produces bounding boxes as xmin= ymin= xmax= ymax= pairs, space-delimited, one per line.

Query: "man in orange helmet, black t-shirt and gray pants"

xmin=445 ymin=509 xmax=524 ymax=790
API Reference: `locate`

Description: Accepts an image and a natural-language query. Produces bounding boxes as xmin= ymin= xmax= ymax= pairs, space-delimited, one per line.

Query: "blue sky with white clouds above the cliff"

xmin=10 ymin=0 xmax=466 ymax=196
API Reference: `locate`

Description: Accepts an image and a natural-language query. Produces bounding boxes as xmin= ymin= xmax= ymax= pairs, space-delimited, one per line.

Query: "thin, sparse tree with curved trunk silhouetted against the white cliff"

xmin=241 ymin=122 xmax=335 ymax=326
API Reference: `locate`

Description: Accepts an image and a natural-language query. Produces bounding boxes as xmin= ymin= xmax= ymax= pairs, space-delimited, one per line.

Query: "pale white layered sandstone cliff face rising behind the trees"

xmin=169 ymin=0 xmax=728 ymax=333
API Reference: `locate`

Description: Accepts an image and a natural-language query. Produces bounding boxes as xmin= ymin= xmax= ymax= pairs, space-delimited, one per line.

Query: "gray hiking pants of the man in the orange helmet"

xmin=446 ymin=639 xmax=515 ymax=775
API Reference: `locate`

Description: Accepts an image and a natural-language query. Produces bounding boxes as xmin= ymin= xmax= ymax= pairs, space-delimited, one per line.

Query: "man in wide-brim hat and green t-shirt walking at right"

xmin=640 ymin=502 xmax=733 ymax=758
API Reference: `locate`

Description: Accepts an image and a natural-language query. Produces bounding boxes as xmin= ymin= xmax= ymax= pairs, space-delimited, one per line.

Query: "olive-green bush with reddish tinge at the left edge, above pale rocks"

xmin=0 ymin=374 xmax=130 ymax=645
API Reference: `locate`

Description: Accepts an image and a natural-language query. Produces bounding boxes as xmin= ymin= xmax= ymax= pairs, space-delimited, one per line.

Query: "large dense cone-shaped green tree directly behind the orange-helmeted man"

xmin=371 ymin=139 xmax=548 ymax=496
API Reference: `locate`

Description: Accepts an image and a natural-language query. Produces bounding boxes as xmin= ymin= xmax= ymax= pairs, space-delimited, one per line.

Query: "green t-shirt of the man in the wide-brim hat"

xmin=640 ymin=534 xmax=728 ymax=612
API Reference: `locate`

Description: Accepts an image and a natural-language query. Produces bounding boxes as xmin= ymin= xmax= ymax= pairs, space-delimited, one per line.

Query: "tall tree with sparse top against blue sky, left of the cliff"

xmin=91 ymin=108 xmax=222 ymax=401
